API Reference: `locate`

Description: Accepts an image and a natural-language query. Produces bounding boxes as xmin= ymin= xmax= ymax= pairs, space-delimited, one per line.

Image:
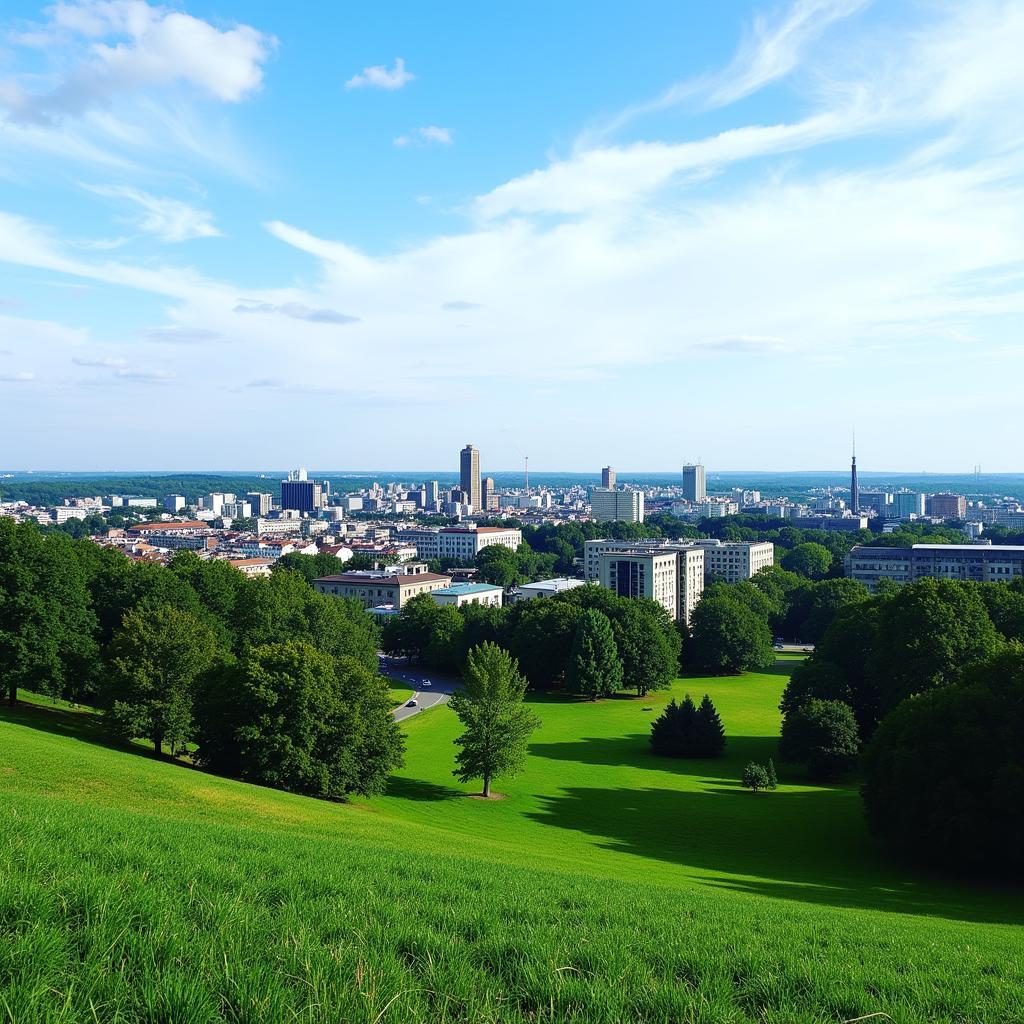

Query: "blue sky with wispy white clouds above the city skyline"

xmin=0 ymin=0 xmax=1024 ymax=472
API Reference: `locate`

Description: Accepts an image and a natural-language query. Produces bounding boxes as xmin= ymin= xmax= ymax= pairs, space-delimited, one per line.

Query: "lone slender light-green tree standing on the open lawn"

xmin=452 ymin=643 xmax=541 ymax=797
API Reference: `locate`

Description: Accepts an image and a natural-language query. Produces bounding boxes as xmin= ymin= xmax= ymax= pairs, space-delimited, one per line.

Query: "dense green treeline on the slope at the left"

xmin=0 ymin=518 xmax=402 ymax=797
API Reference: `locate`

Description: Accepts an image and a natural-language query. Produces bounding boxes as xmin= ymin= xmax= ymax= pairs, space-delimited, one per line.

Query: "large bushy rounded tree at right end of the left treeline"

xmin=197 ymin=640 xmax=402 ymax=798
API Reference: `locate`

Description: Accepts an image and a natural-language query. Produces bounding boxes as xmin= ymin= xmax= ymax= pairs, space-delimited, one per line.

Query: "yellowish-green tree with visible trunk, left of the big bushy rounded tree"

xmin=101 ymin=604 xmax=217 ymax=755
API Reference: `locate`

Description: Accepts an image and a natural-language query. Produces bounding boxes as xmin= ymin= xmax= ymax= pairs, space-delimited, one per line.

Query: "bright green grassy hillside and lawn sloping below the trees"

xmin=0 ymin=663 xmax=1024 ymax=1024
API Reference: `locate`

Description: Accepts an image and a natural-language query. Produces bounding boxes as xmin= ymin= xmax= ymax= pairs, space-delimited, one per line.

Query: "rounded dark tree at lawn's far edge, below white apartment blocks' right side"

xmin=687 ymin=593 xmax=775 ymax=674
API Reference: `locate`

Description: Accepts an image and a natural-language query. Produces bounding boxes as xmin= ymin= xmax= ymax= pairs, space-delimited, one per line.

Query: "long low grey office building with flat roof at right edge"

xmin=846 ymin=544 xmax=1024 ymax=593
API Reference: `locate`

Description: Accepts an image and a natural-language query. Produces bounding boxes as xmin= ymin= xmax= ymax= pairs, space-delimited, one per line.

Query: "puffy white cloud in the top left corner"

xmin=0 ymin=0 xmax=275 ymax=123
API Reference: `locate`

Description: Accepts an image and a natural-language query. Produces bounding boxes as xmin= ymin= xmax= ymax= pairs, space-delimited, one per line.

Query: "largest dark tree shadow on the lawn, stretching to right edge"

xmin=527 ymin=780 xmax=1024 ymax=924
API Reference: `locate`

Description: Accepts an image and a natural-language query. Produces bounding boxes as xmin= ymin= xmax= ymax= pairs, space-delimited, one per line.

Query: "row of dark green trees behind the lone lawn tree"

xmin=381 ymin=586 xmax=681 ymax=697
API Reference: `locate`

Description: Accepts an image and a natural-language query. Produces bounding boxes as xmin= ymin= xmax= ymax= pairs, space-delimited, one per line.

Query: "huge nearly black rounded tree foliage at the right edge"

xmin=861 ymin=648 xmax=1024 ymax=879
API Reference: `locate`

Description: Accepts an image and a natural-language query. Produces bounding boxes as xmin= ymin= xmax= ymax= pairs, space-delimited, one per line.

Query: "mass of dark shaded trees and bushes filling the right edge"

xmin=780 ymin=579 xmax=1024 ymax=871
